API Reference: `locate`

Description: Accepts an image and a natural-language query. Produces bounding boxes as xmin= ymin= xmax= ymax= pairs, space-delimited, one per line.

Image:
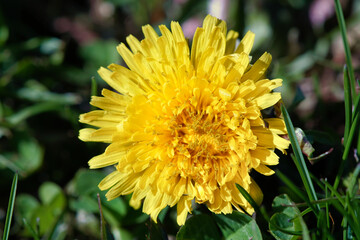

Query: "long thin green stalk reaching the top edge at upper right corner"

xmin=335 ymin=0 xmax=356 ymax=101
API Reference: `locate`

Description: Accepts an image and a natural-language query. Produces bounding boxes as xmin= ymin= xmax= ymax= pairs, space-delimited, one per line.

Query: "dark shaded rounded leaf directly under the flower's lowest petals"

xmin=176 ymin=214 xmax=221 ymax=240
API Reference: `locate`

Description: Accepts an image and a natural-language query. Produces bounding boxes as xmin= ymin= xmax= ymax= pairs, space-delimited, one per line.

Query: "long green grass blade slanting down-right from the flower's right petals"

xmin=281 ymin=105 xmax=320 ymax=211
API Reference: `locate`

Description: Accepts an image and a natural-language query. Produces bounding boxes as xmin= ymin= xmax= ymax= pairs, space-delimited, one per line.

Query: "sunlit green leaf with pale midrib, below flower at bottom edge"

xmin=214 ymin=211 xmax=262 ymax=240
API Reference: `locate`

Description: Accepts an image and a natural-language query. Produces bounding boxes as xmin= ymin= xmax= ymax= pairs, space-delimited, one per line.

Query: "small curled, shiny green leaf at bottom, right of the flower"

xmin=269 ymin=194 xmax=302 ymax=240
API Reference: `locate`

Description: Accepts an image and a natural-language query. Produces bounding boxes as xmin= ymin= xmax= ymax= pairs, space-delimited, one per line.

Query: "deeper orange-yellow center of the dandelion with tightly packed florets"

xmin=162 ymin=104 xmax=231 ymax=181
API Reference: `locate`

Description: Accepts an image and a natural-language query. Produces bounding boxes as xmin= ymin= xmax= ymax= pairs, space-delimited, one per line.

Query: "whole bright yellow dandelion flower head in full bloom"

xmin=79 ymin=15 xmax=289 ymax=225
